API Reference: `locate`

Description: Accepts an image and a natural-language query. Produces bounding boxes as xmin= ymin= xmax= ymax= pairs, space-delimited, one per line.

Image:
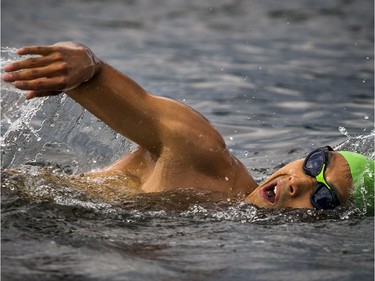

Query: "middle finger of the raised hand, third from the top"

xmin=2 ymin=63 xmax=67 ymax=82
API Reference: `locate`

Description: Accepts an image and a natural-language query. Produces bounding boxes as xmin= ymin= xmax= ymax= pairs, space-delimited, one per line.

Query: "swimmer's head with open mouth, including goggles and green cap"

xmin=246 ymin=147 xmax=374 ymax=213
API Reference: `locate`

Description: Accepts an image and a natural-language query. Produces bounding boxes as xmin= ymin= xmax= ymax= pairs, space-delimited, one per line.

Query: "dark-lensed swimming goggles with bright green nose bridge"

xmin=303 ymin=146 xmax=340 ymax=209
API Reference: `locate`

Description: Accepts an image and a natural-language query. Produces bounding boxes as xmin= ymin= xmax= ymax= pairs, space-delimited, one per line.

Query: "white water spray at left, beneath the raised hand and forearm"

xmin=0 ymin=47 xmax=131 ymax=172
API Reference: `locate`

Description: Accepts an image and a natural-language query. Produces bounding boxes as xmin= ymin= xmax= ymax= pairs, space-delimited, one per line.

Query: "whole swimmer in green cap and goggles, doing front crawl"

xmin=2 ymin=42 xmax=374 ymax=209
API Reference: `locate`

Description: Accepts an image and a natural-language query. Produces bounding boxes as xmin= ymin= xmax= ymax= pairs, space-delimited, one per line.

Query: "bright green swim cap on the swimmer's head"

xmin=338 ymin=151 xmax=374 ymax=215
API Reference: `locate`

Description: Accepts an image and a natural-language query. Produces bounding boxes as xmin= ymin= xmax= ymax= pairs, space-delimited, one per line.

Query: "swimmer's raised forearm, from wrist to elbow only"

xmin=66 ymin=63 xmax=162 ymax=153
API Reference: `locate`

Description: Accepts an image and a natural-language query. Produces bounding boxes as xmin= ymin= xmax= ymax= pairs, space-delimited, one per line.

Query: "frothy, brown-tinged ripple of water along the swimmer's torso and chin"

xmin=1 ymin=162 xmax=362 ymax=225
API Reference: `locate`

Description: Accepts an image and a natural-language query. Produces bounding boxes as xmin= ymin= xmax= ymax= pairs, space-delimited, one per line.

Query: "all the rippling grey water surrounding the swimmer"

xmin=1 ymin=0 xmax=374 ymax=280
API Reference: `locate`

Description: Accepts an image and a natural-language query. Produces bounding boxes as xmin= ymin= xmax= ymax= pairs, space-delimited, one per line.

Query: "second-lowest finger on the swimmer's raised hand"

xmin=13 ymin=76 xmax=67 ymax=91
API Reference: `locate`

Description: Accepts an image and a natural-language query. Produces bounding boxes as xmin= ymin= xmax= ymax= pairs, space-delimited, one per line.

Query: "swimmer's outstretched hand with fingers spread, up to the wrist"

xmin=2 ymin=42 xmax=100 ymax=99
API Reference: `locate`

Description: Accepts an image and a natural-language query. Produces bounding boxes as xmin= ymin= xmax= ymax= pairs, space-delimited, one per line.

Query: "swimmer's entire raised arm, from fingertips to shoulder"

xmin=3 ymin=42 xmax=225 ymax=154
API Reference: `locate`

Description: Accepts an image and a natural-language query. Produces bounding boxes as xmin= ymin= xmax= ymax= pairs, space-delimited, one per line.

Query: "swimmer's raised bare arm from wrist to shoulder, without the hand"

xmin=67 ymin=60 xmax=224 ymax=154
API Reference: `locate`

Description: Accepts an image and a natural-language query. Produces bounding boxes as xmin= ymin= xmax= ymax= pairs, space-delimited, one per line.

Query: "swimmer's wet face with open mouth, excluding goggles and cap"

xmin=245 ymin=151 xmax=352 ymax=209
